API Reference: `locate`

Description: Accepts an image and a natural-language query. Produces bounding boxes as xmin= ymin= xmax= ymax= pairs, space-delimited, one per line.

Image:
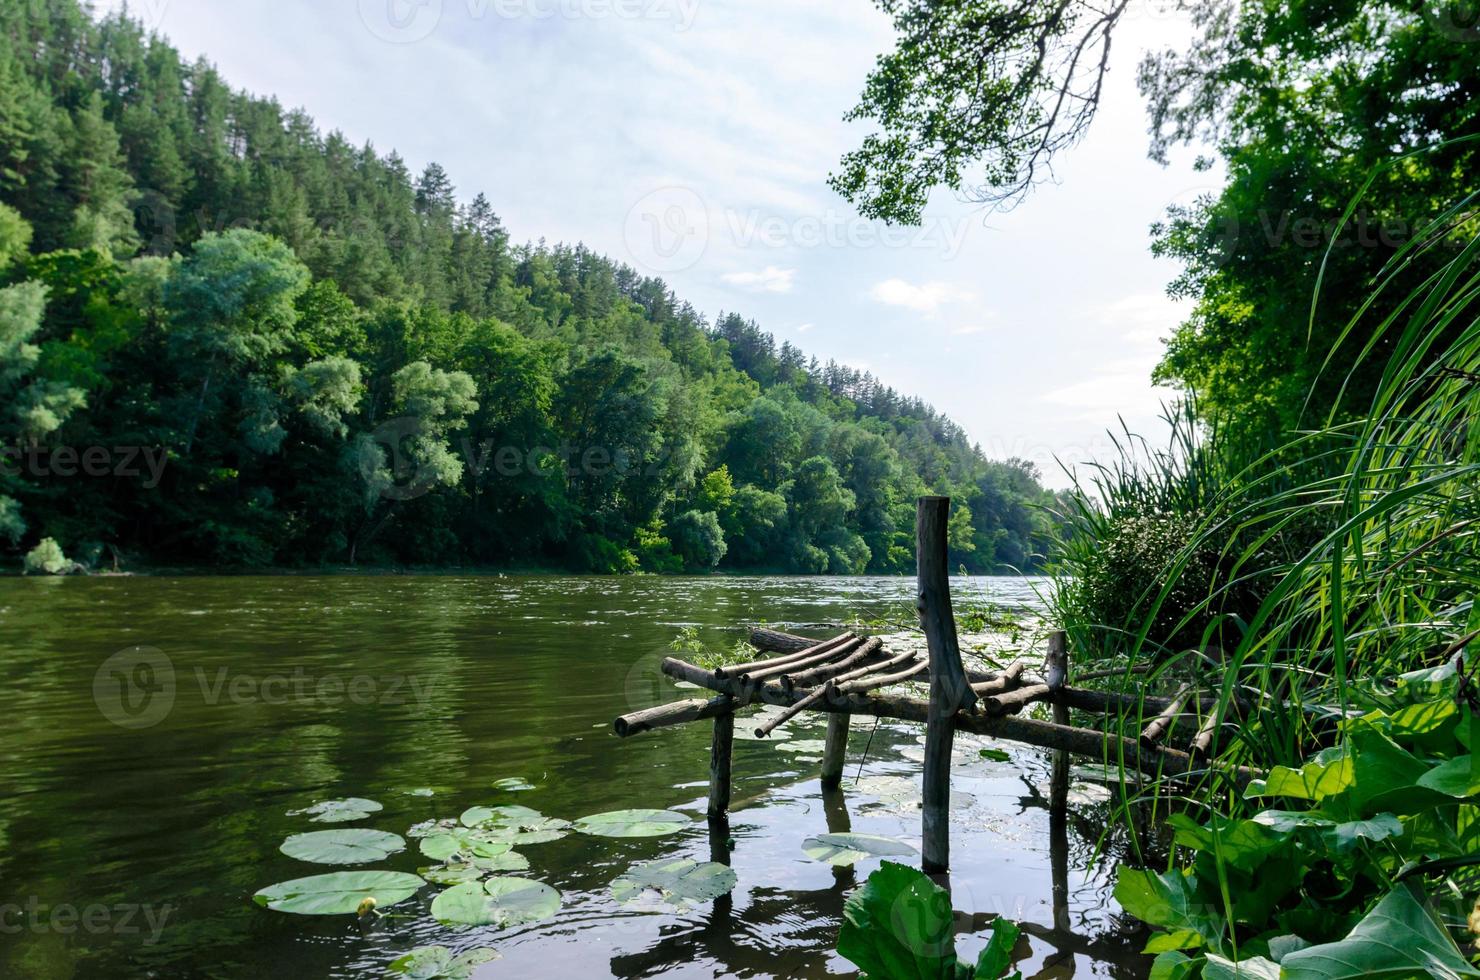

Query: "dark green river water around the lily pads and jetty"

xmin=0 ymin=577 xmax=1147 ymax=979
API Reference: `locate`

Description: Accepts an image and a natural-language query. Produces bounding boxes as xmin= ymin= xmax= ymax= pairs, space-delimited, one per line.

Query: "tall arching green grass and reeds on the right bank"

xmin=1052 ymin=168 xmax=1480 ymax=768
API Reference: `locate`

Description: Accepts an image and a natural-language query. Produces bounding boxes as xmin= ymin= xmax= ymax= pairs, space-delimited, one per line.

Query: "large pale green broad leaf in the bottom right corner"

xmin=1280 ymin=885 xmax=1480 ymax=980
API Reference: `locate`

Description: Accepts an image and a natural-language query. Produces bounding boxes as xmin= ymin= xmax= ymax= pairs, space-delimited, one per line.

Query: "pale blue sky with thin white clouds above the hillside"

xmin=99 ymin=0 xmax=1218 ymax=487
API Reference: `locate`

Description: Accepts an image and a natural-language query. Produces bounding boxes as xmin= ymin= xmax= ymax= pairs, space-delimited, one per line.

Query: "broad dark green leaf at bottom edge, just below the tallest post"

xmin=838 ymin=862 xmax=956 ymax=980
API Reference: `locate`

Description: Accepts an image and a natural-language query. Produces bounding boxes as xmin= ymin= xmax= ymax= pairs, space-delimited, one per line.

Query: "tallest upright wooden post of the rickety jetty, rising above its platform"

xmin=915 ymin=497 xmax=977 ymax=875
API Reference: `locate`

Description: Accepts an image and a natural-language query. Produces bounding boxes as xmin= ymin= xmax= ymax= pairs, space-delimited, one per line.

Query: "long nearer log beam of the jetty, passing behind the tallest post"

xmin=662 ymin=657 xmax=1262 ymax=786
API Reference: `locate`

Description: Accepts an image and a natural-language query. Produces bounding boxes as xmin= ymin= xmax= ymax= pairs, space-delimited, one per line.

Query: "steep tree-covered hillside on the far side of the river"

xmin=0 ymin=0 xmax=1051 ymax=573
